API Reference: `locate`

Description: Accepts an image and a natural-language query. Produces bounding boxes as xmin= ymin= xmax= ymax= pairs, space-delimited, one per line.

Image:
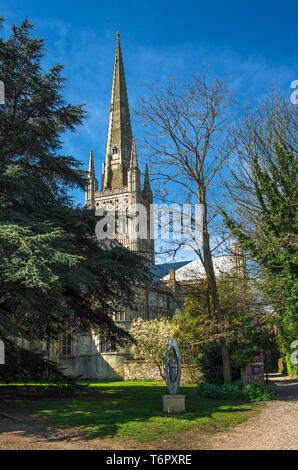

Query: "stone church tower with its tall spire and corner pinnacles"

xmin=86 ymin=32 xmax=154 ymax=264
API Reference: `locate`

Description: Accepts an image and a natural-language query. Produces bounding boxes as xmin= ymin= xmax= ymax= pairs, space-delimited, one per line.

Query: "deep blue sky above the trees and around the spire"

xmin=0 ymin=0 xmax=298 ymax=260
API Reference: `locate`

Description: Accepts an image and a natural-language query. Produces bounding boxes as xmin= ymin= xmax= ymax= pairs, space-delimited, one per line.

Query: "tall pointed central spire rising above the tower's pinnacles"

xmin=105 ymin=32 xmax=132 ymax=189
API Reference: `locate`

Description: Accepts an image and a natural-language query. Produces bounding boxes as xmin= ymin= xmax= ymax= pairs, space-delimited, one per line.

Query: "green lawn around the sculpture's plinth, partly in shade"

xmin=7 ymin=382 xmax=258 ymax=443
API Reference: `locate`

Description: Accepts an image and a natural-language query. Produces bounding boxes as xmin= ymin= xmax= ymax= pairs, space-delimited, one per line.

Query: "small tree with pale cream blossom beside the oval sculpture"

xmin=130 ymin=318 xmax=176 ymax=380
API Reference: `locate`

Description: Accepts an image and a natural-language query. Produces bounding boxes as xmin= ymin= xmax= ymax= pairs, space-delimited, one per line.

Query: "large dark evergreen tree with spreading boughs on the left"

xmin=0 ymin=20 xmax=147 ymax=352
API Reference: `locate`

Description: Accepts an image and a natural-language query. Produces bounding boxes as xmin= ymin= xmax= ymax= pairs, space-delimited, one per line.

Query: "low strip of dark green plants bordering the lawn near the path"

xmin=198 ymin=381 xmax=276 ymax=401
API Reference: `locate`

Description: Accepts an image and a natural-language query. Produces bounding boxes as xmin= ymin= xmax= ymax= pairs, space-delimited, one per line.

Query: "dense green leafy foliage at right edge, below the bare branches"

xmin=223 ymin=143 xmax=298 ymax=362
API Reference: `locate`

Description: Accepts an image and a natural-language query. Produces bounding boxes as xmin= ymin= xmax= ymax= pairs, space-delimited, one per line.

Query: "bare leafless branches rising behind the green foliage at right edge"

xmin=225 ymin=90 xmax=298 ymax=233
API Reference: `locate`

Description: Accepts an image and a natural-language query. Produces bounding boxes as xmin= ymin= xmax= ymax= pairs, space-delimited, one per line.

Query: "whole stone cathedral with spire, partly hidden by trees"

xmin=25 ymin=33 xmax=240 ymax=380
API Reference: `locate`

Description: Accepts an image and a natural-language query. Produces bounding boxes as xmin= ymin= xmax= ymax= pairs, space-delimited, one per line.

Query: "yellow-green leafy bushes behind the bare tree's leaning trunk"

xmin=174 ymin=280 xmax=276 ymax=384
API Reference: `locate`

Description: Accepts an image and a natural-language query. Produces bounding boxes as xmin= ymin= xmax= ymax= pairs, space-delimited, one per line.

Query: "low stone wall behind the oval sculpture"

xmin=123 ymin=360 xmax=202 ymax=384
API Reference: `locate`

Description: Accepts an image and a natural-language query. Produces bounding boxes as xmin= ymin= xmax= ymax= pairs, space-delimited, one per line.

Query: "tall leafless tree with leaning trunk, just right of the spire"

xmin=138 ymin=75 xmax=235 ymax=383
